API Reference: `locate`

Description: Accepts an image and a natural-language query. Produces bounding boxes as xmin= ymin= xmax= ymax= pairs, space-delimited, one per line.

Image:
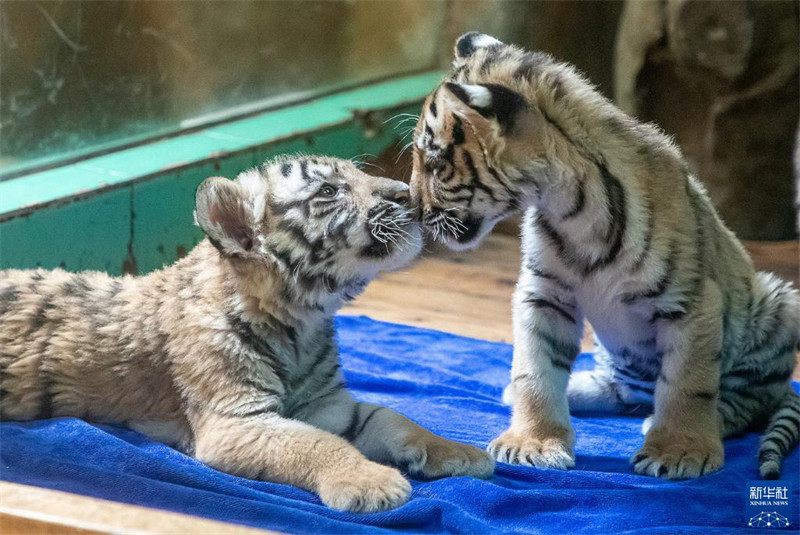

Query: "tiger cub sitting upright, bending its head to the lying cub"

xmin=412 ymin=33 xmax=800 ymax=478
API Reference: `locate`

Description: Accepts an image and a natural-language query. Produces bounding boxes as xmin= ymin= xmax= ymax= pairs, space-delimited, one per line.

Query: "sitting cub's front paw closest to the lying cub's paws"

xmin=489 ymin=429 xmax=575 ymax=469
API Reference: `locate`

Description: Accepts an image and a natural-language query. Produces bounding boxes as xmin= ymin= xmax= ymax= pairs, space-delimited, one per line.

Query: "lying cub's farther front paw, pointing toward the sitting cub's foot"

xmin=397 ymin=434 xmax=494 ymax=479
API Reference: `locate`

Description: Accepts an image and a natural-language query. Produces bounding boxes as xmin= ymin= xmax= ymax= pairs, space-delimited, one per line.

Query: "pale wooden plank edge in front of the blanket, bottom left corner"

xmin=0 ymin=481 xmax=277 ymax=535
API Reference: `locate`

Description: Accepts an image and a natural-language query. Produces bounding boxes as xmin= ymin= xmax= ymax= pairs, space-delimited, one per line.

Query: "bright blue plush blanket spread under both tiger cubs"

xmin=0 ymin=317 xmax=800 ymax=535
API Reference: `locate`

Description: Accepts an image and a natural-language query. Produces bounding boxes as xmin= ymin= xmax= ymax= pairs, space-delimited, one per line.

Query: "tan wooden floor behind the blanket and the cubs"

xmin=342 ymin=233 xmax=800 ymax=380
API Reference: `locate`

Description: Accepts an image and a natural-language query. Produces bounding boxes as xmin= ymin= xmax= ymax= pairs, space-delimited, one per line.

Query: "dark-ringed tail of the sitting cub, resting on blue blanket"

xmin=758 ymin=390 xmax=800 ymax=479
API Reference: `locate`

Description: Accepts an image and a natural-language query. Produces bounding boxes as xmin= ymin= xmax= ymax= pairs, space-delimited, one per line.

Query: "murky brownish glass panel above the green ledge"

xmin=0 ymin=0 xmax=447 ymax=177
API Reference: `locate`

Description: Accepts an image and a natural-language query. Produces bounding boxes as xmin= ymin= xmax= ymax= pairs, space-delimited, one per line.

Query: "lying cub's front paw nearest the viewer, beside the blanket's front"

xmin=318 ymin=460 xmax=411 ymax=513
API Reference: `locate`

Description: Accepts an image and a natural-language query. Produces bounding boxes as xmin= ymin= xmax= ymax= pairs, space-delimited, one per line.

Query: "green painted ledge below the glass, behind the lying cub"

xmin=0 ymin=72 xmax=443 ymax=274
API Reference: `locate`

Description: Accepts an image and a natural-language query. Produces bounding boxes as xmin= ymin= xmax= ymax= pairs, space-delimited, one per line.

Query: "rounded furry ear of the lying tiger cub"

xmin=194 ymin=177 xmax=255 ymax=256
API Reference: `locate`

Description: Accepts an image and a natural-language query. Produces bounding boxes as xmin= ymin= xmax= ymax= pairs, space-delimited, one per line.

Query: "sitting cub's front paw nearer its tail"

xmin=631 ymin=427 xmax=724 ymax=479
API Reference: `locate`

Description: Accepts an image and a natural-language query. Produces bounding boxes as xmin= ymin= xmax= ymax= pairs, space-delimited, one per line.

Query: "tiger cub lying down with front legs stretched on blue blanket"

xmin=0 ymin=157 xmax=493 ymax=512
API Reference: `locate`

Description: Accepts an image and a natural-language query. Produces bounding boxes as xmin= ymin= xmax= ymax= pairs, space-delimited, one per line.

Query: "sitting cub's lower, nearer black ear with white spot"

xmin=445 ymin=83 xmax=528 ymax=134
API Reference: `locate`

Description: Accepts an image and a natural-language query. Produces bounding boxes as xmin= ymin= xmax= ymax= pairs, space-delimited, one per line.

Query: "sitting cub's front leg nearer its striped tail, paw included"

xmin=631 ymin=279 xmax=723 ymax=479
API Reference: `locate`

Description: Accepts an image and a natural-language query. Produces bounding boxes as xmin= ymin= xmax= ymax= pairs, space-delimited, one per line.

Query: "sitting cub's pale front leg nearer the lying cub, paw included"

xmin=489 ymin=289 xmax=583 ymax=468
